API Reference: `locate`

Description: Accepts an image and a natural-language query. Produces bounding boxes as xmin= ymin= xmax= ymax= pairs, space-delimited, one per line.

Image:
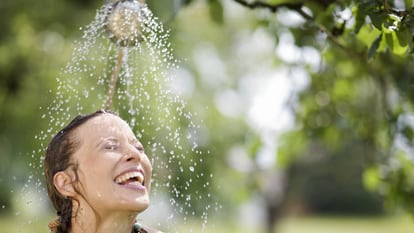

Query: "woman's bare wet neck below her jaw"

xmin=71 ymin=200 xmax=137 ymax=233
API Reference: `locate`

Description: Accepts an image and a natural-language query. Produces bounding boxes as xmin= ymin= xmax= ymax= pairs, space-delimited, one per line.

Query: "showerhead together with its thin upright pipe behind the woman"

xmin=105 ymin=0 xmax=147 ymax=109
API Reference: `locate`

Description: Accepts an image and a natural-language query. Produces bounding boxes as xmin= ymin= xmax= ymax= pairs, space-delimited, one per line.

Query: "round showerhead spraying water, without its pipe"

xmin=105 ymin=0 xmax=148 ymax=47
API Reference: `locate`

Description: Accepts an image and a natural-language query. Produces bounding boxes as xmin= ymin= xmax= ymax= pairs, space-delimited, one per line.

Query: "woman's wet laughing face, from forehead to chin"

xmin=73 ymin=114 xmax=152 ymax=214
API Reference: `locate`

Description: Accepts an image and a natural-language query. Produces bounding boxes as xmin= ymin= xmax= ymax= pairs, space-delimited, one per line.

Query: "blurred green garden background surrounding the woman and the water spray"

xmin=0 ymin=0 xmax=414 ymax=233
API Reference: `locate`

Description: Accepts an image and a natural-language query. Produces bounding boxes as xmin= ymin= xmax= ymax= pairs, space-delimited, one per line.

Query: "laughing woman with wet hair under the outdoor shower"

xmin=44 ymin=110 xmax=159 ymax=233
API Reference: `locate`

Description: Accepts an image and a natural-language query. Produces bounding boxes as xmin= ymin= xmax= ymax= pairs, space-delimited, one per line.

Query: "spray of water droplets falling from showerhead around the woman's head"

xmin=25 ymin=1 xmax=217 ymax=232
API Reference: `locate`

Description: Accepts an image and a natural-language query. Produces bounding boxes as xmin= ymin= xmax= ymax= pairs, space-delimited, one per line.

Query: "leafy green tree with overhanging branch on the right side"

xmin=163 ymin=0 xmax=414 ymax=232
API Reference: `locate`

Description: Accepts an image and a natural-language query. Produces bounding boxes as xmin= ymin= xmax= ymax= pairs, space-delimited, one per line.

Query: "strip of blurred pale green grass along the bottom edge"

xmin=0 ymin=216 xmax=414 ymax=233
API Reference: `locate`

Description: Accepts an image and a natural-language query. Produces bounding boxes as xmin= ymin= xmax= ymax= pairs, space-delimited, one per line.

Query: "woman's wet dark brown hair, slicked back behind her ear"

xmin=44 ymin=110 xmax=117 ymax=233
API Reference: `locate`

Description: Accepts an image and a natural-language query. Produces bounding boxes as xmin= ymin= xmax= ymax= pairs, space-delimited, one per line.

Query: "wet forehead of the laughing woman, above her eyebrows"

xmin=76 ymin=114 xmax=135 ymax=140
